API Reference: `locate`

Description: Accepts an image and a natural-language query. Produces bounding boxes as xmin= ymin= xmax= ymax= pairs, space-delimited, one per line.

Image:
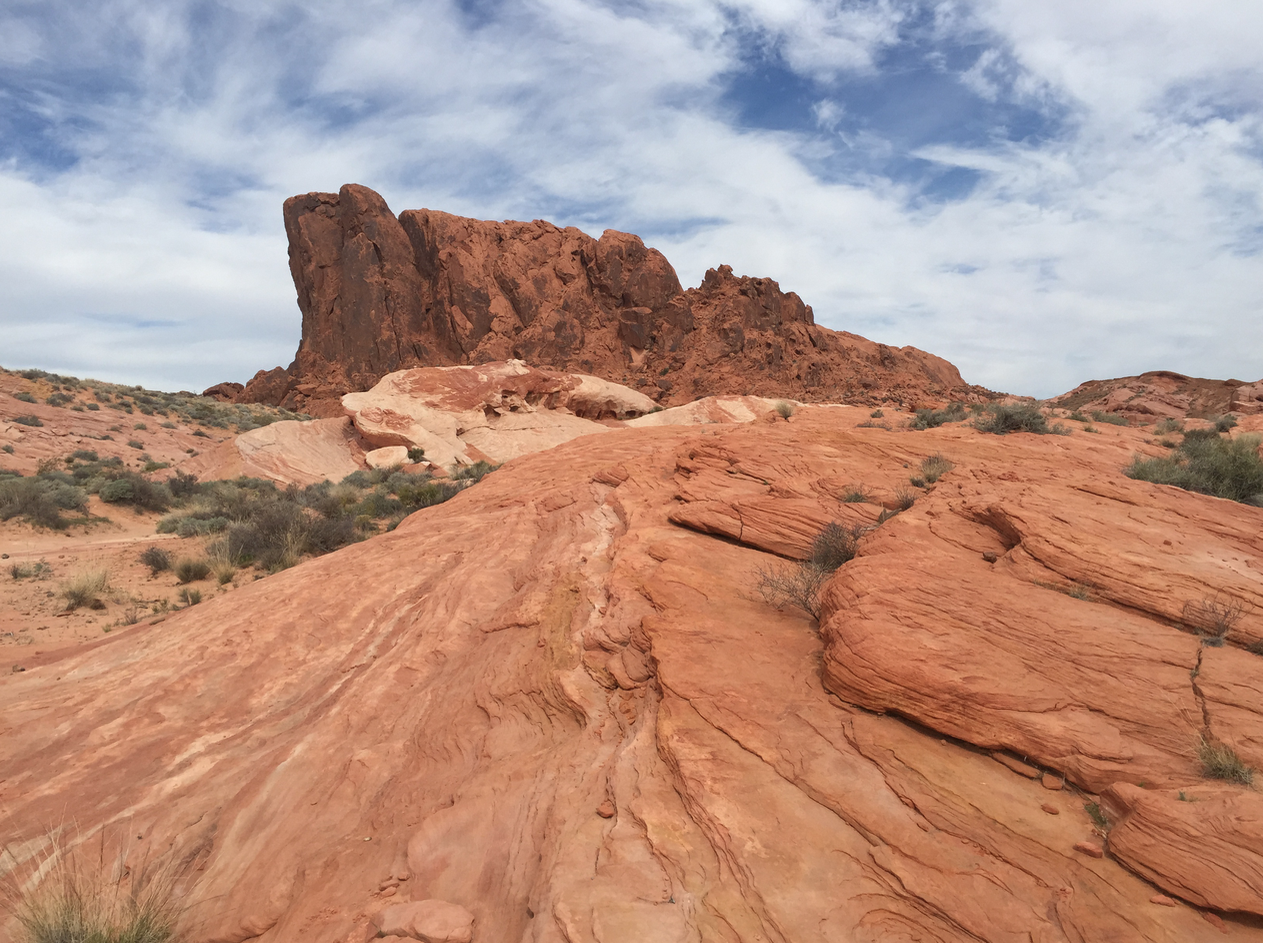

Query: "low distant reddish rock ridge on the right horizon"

xmin=1048 ymin=370 xmax=1263 ymax=424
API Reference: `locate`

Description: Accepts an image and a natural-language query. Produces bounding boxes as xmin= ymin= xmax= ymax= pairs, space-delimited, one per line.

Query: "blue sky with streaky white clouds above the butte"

xmin=0 ymin=0 xmax=1263 ymax=396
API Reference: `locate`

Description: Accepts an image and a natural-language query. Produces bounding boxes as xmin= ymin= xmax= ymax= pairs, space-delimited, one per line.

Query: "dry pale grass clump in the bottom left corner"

xmin=4 ymin=839 xmax=181 ymax=943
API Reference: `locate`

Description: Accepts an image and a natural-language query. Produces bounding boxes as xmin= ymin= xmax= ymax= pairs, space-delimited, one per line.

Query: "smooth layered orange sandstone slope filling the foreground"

xmin=0 ymin=406 xmax=1263 ymax=943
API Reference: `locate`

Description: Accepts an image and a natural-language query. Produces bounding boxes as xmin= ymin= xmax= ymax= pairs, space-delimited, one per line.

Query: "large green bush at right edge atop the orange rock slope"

xmin=1124 ymin=429 xmax=1263 ymax=506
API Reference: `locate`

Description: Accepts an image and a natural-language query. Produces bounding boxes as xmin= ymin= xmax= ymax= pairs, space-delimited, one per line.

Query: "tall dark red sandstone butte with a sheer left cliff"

xmin=206 ymin=184 xmax=991 ymax=417
